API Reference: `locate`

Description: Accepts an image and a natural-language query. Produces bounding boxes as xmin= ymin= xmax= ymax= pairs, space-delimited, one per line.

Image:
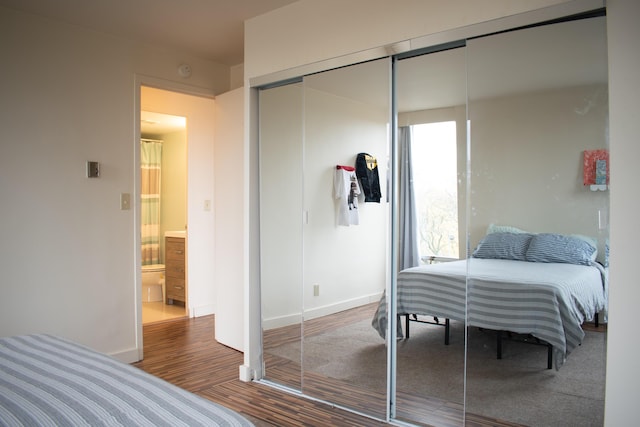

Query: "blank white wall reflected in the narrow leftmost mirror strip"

xmin=252 ymin=83 xmax=304 ymax=330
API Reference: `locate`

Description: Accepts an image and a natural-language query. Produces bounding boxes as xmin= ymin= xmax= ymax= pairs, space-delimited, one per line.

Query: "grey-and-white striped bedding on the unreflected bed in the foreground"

xmin=0 ymin=335 xmax=252 ymax=426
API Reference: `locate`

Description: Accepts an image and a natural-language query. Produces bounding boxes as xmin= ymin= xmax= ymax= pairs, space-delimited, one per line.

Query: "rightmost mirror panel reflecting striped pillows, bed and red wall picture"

xmin=466 ymin=17 xmax=609 ymax=426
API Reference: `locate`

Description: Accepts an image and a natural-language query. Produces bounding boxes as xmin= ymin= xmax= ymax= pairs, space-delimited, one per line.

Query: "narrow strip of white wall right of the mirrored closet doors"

xmin=605 ymin=0 xmax=640 ymax=427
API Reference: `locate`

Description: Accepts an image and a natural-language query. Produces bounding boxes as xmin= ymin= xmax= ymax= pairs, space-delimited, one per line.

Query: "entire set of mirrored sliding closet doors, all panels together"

xmin=258 ymin=10 xmax=609 ymax=426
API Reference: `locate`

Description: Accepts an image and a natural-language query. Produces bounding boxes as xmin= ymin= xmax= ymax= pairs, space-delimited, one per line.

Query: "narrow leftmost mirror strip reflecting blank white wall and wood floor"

xmin=258 ymin=83 xmax=303 ymax=390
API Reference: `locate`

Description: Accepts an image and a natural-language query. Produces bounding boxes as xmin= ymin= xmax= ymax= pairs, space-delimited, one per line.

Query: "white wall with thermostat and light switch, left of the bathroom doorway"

xmin=0 ymin=8 xmax=229 ymax=361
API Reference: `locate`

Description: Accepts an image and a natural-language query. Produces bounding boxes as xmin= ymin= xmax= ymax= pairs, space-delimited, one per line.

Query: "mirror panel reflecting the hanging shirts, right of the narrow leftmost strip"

xmin=301 ymin=58 xmax=390 ymax=418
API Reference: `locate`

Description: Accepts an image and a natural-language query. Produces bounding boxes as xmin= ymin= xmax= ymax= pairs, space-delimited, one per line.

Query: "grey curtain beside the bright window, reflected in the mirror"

xmin=398 ymin=126 xmax=420 ymax=270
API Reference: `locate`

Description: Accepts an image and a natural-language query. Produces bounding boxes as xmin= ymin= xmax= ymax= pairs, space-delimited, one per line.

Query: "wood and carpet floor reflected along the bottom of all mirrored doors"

xmin=263 ymin=304 xmax=606 ymax=427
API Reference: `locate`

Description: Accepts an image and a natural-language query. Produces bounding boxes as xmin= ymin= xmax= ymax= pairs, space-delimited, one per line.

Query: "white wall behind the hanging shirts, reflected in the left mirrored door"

xmin=260 ymin=81 xmax=389 ymax=329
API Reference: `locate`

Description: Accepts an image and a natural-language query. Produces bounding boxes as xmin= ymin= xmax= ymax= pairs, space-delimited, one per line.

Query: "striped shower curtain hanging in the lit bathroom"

xmin=140 ymin=140 xmax=162 ymax=265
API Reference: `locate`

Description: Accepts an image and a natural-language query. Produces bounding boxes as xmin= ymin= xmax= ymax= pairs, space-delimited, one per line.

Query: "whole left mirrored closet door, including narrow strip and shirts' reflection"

xmin=259 ymin=58 xmax=391 ymax=418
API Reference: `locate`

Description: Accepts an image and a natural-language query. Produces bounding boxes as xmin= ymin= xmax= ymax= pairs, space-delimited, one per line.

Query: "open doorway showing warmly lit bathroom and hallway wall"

xmin=135 ymin=83 xmax=215 ymax=327
